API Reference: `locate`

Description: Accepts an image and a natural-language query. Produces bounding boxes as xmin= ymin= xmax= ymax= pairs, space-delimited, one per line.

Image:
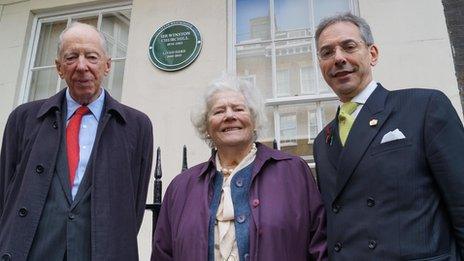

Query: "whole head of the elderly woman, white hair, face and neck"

xmin=191 ymin=74 xmax=265 ymax=174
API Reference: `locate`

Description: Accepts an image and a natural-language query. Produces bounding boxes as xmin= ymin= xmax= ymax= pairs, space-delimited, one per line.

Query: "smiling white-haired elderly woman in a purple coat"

xmin=152 ymin=76 xmax=327 ymax=261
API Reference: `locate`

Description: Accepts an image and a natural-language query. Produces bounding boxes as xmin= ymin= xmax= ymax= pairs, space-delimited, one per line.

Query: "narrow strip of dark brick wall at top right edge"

xmin=442 ymin=0 xmax=464 ymax=114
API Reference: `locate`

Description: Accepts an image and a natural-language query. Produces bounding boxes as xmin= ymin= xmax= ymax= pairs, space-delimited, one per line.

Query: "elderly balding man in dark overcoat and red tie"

xmin=0 ymin=23 xmax=153 ymax=261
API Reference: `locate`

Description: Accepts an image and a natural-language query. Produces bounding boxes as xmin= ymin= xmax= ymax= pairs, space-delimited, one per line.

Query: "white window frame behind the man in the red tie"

xmin=17 ymin=1 xmax=132 ymax=104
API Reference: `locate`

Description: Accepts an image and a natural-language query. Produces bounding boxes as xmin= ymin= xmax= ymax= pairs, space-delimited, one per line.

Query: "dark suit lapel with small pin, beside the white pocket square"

xmin=334 ymin=84 xmax=391 ymax=200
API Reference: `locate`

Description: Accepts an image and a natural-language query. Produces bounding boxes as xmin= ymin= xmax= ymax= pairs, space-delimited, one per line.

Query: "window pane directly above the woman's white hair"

xmin=237 ymin=44 xmax=273 ymax=98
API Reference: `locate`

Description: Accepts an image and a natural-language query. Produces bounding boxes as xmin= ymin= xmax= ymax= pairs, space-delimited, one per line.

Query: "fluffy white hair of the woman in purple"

xmin=191 ymin=74 xmax=266 ymax=148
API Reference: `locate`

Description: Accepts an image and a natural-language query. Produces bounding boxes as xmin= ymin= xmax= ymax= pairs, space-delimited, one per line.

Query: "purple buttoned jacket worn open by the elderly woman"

xmin=151 ymin=143 xmax=327 ymax=261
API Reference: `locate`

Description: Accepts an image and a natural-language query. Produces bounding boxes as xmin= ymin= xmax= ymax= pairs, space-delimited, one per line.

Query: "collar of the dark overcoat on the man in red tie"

xmin=37 ymin=88 xmax=127 ymax=123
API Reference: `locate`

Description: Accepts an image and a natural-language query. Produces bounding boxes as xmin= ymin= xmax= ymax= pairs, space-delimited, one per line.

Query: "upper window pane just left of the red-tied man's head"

xmin=34 ymin=20 xmax=66 ymax=67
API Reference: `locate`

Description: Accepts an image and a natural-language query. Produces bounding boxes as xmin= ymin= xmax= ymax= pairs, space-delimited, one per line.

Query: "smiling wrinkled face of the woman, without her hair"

xmin=207 ymin=91 xmax=254 ymax=150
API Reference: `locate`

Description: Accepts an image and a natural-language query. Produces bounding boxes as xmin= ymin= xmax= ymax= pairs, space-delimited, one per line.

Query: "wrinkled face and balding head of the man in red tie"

xmin=55 ymin=26 xmax=111 ymax=105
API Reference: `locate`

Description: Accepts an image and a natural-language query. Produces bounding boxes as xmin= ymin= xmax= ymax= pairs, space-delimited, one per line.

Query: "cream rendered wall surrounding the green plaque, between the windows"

xmin=122 ymin=0 xmax=227 ymax=260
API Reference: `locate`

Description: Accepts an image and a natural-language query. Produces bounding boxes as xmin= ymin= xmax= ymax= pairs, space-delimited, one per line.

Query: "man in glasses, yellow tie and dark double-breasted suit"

xmin=314 ymin=14 xmax=464 ymax=260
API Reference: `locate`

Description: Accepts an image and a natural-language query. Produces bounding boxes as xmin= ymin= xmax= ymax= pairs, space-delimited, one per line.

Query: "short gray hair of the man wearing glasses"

xmin=316 ymin=13 xmax=374 ymax=46
